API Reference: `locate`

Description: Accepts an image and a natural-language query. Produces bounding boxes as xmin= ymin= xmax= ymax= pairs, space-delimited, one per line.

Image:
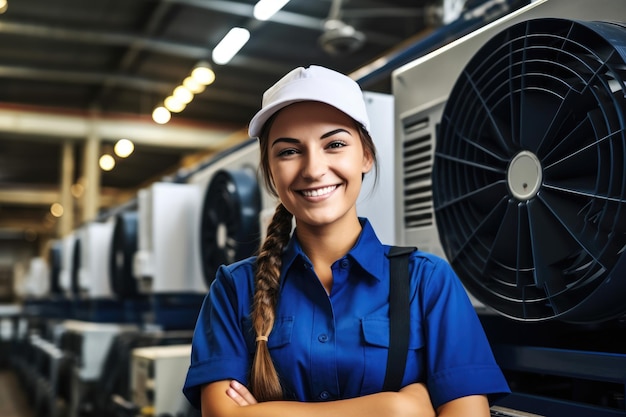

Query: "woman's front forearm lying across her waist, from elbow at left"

xmin=202 ymin=381 xmax=432 ymax=417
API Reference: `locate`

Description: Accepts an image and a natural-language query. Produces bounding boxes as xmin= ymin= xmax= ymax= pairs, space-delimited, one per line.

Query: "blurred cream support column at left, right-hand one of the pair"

xmin=82 ymin=128 xmax=100 ymax=222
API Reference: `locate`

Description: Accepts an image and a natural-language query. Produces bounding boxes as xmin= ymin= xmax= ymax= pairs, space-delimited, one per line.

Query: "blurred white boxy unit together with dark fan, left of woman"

xmin=132 ymin=141 xmax=273 ymax=329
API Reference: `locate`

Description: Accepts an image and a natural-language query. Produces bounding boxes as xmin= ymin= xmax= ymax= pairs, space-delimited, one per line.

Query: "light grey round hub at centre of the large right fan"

xmin=506 ymin=151 xmax=542 ymax=201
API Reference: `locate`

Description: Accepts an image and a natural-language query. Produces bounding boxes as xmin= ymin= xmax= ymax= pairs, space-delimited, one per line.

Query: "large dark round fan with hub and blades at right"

xmin=432 ymin=18 xmax=626 ymax=323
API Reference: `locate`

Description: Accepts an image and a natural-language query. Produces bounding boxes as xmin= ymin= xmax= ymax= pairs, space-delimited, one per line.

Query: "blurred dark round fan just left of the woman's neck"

xmin=200 ymin=168 xmax=261 ymax=287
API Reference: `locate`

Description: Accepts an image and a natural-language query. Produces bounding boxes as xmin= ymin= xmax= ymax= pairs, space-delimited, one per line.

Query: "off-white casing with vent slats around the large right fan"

xmin=392 ymin=0 xmax=626 ymax=315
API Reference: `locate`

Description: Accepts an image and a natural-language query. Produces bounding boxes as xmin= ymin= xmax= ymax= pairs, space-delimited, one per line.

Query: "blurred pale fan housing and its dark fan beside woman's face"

xmin=187 ymin=139 xmax=276 ymax=290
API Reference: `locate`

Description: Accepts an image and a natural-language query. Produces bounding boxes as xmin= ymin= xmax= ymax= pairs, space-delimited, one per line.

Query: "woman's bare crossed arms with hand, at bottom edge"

xmin=202 ymin=381 xmax=489 ymax=417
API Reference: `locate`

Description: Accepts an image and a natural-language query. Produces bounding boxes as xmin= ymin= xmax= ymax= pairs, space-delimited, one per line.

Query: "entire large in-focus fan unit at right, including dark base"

xmin=393 ymin=0 xmax=626 ymax=417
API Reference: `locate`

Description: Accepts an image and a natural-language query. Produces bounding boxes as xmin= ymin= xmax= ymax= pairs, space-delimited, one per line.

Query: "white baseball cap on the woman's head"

xmin=248 ymin=65 xmax=370 ymax=138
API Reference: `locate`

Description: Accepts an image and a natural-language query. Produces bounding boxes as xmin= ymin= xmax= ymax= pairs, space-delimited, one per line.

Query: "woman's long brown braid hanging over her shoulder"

xmin=250 ymin=204 xmax=292 ymax=402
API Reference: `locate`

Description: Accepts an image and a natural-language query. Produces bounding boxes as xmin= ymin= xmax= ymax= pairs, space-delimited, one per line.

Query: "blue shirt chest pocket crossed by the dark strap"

xmin=361 ymin=317 xmax=425 ymax=395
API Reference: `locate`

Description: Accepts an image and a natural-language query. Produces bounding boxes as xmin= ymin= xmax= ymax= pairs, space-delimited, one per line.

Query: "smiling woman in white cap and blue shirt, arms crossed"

xmin=183 ymin=66 xmax=508 ymax=417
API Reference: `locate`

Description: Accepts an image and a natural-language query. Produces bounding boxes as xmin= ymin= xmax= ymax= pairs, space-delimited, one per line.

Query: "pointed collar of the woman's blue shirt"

xmin=281 ymin=218 xmax=385 ymax=281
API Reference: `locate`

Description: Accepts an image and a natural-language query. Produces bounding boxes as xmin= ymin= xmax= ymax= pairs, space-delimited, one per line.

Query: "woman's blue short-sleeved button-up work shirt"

xmin=183 ymin=219 xmax=509 ymax=408
